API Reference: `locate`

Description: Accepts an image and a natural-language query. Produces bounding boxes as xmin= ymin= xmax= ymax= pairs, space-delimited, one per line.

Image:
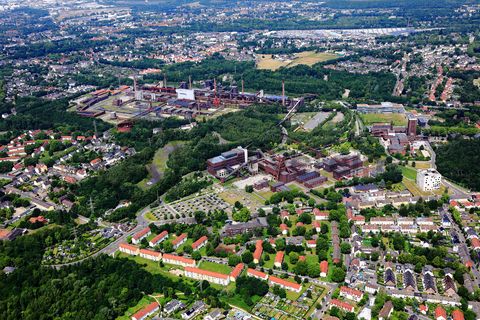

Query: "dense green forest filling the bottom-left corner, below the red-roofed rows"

xmin=0 ymin=228 xmax=199 ymax=320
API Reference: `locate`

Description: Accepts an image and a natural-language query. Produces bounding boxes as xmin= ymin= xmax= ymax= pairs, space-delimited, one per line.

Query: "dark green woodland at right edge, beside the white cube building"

xmin=436 ymin=139 xmax=480 ymax=191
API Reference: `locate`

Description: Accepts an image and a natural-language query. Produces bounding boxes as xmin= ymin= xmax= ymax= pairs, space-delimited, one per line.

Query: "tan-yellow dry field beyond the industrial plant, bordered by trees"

xmin=257 ymin=51 xmax=338 ymax=71
